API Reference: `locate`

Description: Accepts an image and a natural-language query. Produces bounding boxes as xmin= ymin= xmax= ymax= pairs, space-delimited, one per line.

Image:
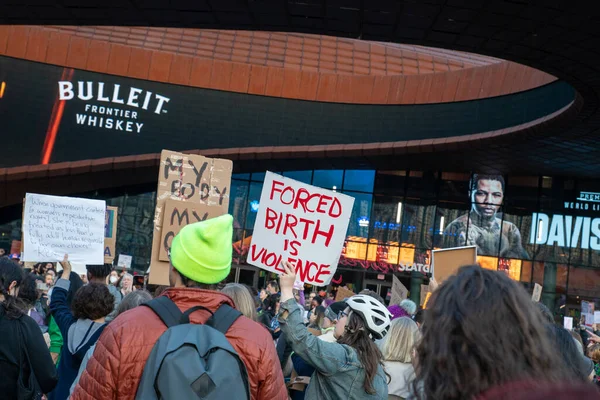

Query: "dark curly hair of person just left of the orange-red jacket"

xmin=71 ymin=283 xmax=115 ymax=320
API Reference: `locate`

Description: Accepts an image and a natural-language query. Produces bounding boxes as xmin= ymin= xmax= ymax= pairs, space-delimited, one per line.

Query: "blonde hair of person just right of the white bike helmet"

xmin=381 ymin=317 xmax=421 ymax=363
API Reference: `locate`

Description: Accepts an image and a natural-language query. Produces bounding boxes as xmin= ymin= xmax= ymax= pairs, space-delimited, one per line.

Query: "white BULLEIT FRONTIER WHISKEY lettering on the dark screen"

xmin=58 ymin=81 xmax=170 ymax=133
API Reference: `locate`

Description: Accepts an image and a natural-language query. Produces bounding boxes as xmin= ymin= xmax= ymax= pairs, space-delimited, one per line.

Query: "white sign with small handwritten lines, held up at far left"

xmin=23 ymin=193 xmax=106 ymax=264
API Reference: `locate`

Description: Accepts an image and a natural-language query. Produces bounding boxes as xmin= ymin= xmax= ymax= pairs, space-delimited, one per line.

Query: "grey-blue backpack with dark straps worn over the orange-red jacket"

xmin=135 ymin=296 xmax=250 ymax=400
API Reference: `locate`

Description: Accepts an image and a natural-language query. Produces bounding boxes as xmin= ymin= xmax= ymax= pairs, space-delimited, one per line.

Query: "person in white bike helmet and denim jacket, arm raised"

xmin=279 ymin=262 xmax=391 ymax=400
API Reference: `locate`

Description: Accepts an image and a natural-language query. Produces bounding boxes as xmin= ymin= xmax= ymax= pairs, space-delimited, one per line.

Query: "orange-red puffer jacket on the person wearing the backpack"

xmin=71 ymin=288 xmax=288 ymax=400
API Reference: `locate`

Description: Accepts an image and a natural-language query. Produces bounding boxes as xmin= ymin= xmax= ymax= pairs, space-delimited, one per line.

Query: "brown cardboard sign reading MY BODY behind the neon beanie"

xmin=149 ymin=150 xmax=233 ymax=285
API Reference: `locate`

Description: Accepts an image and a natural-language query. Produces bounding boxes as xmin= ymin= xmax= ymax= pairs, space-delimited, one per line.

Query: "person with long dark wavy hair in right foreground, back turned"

xmin=412 ymin=265 xmax=600 ymax=400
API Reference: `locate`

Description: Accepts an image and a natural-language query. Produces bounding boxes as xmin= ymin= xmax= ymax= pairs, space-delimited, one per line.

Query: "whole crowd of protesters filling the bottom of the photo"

xmin=0 ymin=211 xmax=600 ymax=400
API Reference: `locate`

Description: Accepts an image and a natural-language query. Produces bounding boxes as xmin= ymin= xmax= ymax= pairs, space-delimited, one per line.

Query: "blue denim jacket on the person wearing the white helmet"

xmin=279 ymin=299 xmax=388 ymax=400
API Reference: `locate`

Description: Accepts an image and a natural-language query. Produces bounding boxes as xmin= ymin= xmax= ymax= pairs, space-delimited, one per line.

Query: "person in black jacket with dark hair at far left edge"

xmin=0 ymin=257 xmax=58 ymax=399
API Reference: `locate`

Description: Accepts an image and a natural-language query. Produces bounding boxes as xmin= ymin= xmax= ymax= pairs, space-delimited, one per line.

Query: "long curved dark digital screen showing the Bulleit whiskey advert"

xmin=0 ymin=57 xmax=575 ymax=167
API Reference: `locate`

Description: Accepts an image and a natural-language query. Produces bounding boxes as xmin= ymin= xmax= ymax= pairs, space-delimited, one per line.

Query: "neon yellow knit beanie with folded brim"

xmin=171 ymin=214 xmax=233 ymax=285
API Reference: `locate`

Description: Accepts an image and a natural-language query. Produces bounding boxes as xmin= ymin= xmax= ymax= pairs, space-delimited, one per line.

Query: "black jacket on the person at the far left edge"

xmin=0 ymin=306 xmax=58 ymax=399
